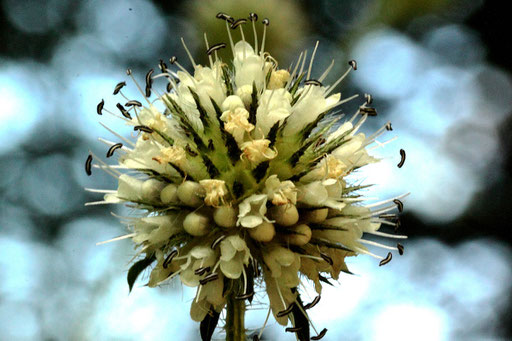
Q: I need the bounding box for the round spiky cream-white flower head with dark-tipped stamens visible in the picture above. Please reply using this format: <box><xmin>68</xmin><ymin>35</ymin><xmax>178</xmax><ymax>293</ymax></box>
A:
<box><xmin>86</xmin><ymin>14</ymin><xmax>403</xmax><ymax>333</ymax></box>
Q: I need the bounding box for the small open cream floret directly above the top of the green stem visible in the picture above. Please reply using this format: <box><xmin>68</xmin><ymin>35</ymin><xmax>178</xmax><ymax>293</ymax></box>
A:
<box><xmin>220</xmin><ymin>235</ymin><xmax>251</xmax><ymax>279</ymax></box>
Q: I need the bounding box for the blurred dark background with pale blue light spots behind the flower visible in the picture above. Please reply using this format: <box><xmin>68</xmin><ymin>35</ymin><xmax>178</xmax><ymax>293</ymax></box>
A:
<box><xmin>0</xmin><ymin>0</ymin><xmax>512</xmax><ymax>341</ymax></box>
